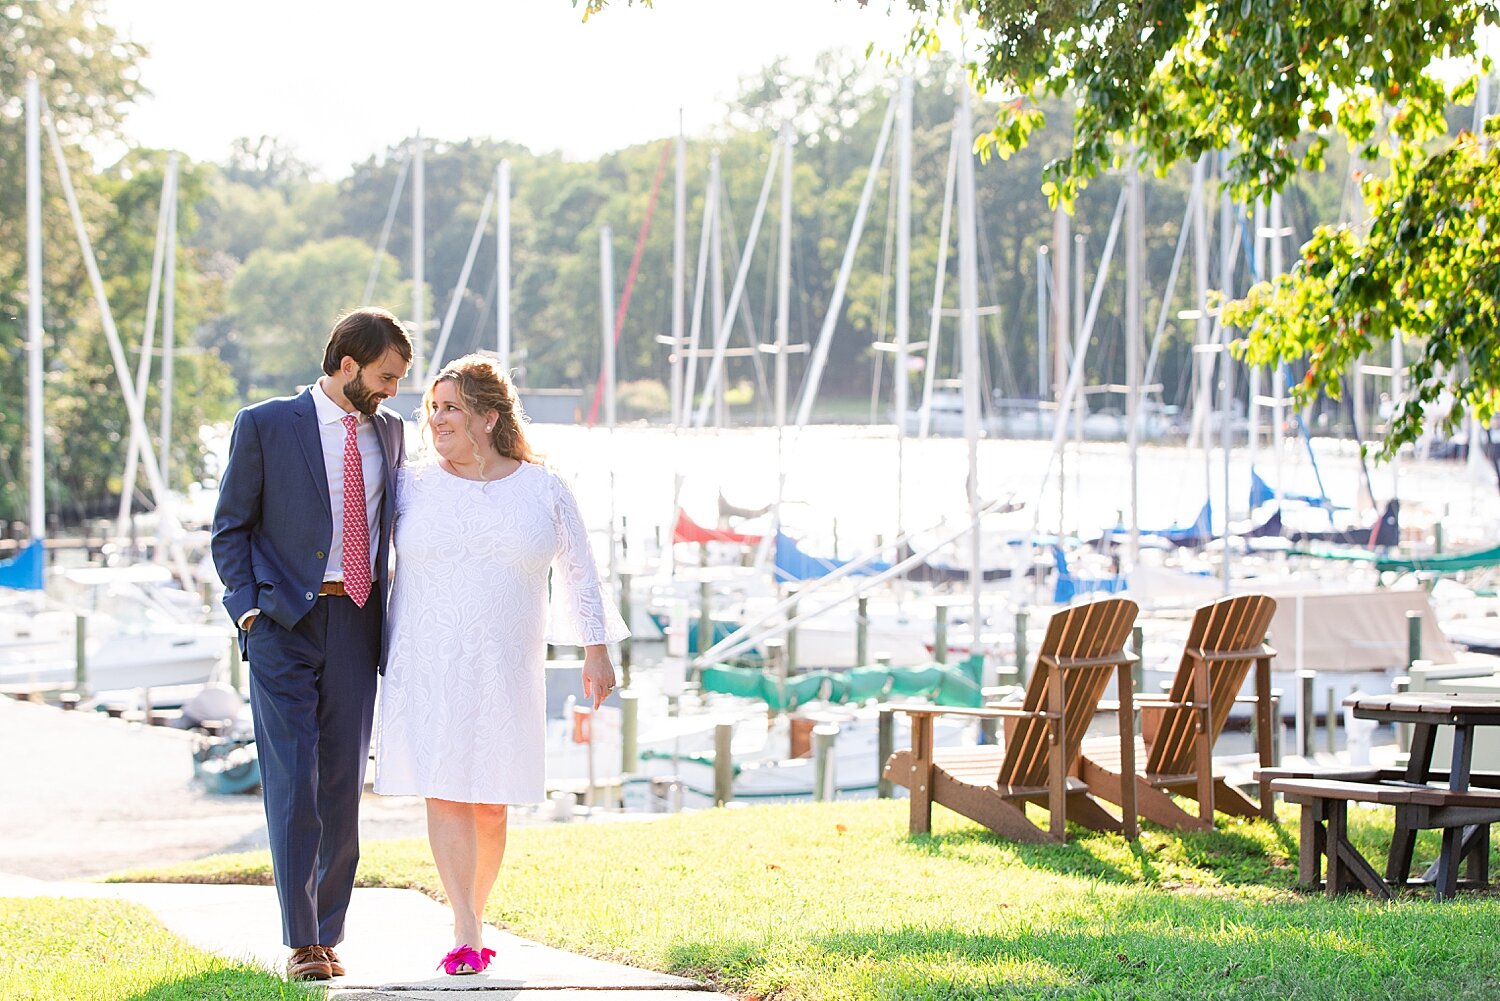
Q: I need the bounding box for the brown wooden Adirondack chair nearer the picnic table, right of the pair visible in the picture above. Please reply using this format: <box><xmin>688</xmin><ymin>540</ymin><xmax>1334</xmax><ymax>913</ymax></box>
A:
<box><xmin>1079</xmin><ymin>594</ymin><xmax>1277</xmax><ymax>830</ymax></box>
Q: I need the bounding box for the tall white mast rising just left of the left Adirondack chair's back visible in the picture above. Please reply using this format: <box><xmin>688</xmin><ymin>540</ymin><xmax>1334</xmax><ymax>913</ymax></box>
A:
<box><xmin>959</xmin><ymin>81</ymin><xmax>996</xmax><ymax>686</ymax></box>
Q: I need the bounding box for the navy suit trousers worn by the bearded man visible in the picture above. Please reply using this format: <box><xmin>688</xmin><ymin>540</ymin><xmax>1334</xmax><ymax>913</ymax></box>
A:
<box><xmin>246</xmin><ymin>585</ymin><xmax>381</xmax><ymax>948</ymax></box>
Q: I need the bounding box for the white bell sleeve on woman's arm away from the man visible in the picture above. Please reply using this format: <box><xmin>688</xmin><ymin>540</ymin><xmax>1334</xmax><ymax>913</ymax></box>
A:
<box><xmin>548</xmin><ymin>474</ymin><xmax>630</xmax><ymax>647</ymax></box>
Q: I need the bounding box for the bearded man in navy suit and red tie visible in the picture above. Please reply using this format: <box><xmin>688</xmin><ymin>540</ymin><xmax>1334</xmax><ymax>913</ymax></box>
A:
<box><xmin>213</xmin><ymin>309</ymin><xmax>411</xmax><ymax>980</ymax></box>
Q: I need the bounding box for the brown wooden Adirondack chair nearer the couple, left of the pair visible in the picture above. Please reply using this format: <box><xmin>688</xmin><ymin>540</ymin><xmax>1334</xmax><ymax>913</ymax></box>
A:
<box><xmin>885</xmin><ymin>597</ymin><xmax>1137</xmax><ymax>842</ymax></box>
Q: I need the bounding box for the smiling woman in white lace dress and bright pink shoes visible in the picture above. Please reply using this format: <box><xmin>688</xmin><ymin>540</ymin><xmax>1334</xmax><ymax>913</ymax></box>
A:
<box><xmin>375</xmin><ymin>354</ymin><xmax>629</xmax><ymax>974</ymax></box>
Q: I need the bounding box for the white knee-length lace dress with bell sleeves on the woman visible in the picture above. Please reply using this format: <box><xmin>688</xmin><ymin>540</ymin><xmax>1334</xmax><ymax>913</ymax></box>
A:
<box><xmin>375</xmin><ymin>462</ymin><xmax>629</xmax><ymax>803</ymax></box>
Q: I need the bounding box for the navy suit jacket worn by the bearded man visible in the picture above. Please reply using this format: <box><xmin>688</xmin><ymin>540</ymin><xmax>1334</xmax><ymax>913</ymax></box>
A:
<box><xmin>212</xmin><ymin>389</ymin><xmax>407</xmax><ymax>668</ymax></box>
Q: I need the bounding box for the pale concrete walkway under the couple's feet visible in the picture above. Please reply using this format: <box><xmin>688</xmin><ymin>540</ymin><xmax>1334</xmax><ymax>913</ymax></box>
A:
<box><xmin>0</xmin><ymin>876</ymin><xmax>726</xmax><ymax>1001</ymax></box>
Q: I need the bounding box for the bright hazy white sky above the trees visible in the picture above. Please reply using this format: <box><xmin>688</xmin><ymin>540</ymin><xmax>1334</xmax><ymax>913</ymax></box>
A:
<box><xmin>107</xmin><ymin>0</ymin><xmax>909</xmax><ymax>177</ymax></box>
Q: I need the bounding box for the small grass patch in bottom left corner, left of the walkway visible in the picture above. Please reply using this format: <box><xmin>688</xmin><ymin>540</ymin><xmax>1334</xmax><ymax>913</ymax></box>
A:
<box><xmin>0</xmin><ymin>897</ymin><xmax>324</xmax><ymax>1001</ymax></box>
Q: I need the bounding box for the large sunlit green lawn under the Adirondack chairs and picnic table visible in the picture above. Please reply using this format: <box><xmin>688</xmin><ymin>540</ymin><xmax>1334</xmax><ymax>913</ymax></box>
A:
<box><xmin>108</xmin><ymin>801</ymin><xmax>1500</xmax><ymax>1001</ymax></box>
